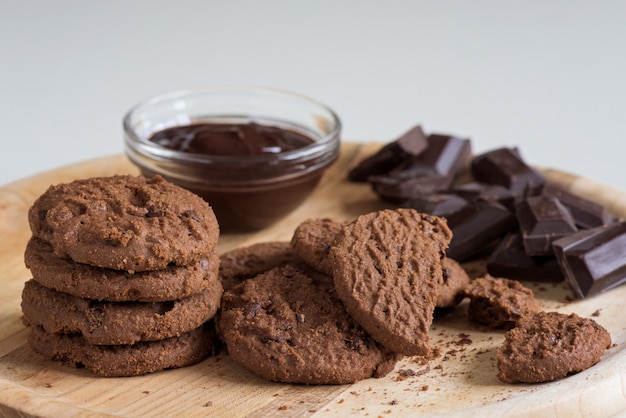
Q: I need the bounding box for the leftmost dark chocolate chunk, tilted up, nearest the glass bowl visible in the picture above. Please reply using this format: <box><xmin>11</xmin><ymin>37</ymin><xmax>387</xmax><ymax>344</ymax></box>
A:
<box><xmin>348</xmin><ymin>125</ymin><xmax>427</xmax><ymax>182</ymax></box>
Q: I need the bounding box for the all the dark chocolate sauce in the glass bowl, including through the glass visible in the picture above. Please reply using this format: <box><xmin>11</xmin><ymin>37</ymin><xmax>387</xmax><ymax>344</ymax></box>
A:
<box><xmin>142</xmin><ymin>122</ymin><xmax>324</xmax><ymax>232</ymax></box>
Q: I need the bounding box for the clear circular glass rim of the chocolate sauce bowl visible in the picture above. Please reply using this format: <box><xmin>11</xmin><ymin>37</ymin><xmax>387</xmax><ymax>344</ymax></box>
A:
<box><xmin>122</xmin><ymin>84</ymin><xmax>342</xmax><ymax>164</ymax></box>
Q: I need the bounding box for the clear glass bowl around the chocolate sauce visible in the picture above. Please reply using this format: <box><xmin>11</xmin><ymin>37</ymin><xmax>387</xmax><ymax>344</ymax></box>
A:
<box><xmin>123</xmin><ymin>86</ymin><xmax>341</xmax><ymax>232</ymax></box>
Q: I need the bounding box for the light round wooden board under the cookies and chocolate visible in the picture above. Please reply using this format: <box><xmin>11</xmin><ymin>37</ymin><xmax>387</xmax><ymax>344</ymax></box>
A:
<box><xmin>0</xmin><ymin>143</ymin><xmax>626</xmax><ymax>417</ymax></box>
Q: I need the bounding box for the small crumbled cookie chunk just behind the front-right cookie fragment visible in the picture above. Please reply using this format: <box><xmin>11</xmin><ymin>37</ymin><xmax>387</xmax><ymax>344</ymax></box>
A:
<box><xmin>463</xmin><ymin>274</ymin><xmax>541</xmax><ymax>329</ymax></box>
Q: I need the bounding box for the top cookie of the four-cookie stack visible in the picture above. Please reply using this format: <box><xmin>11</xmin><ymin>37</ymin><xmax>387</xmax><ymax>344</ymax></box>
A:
<box><xmin>28</xmin><ymin>176</ymin><xmax>219</xmax><ymax>271</ymax></box>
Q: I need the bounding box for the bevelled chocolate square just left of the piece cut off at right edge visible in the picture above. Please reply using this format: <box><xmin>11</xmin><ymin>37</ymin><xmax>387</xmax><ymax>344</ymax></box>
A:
<box><xmin>516</xmin><ymin>195</ymin><xmax>578</xmax><ymax>255</ymax></box>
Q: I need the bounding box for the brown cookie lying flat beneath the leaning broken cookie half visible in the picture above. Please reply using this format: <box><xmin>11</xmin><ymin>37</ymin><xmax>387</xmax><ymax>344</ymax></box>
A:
<box><xmin>218</xmin><ymin>264</ymin><xmax>398</xmax><ymax>384</ymax></box>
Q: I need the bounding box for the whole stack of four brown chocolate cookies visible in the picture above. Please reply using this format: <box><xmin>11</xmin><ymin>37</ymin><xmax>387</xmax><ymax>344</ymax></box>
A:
<box><xmin>22</xmin><ymin>176</ymin><xmax>223</xmax><ymax>376</ymax></box>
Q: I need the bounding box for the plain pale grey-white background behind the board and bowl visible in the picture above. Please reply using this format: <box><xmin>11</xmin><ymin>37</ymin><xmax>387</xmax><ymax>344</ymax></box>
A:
<box><xmin>0</xmin><ymin>0</ymin><xmax>626</xmax><ymax>190</ymax></box>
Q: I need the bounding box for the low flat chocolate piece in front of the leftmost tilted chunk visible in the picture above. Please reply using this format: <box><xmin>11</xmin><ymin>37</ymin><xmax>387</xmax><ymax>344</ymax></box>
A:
<box><xmin>368</xmin><ymin>174</ymin><xmax>453</xmax><ymax>202</ymax></box>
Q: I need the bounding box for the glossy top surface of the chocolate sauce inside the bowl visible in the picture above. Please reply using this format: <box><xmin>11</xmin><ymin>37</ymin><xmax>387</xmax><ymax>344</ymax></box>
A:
<box><xmin>149</xmin><ymin>122</ymin><xmax>314</xmax><ymax>155</ymax></box>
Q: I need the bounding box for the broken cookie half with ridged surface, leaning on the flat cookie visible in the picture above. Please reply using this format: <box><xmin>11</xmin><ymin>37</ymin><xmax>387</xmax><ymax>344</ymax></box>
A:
<box><xmin>330</xmin><ymin>209</ymin><xmax>452</xmax><ymax>355</ymax></box>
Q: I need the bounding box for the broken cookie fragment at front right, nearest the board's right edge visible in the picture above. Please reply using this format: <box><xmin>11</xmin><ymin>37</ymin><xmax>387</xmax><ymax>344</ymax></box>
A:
<box><xmin>498</xmin><ymin>312</ymin><xmax>611</xmax><ymax>383</ymax></box>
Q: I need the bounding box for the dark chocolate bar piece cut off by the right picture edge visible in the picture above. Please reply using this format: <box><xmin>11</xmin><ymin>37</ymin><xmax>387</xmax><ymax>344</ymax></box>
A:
<box><xmin>552</xmin><ymin>221</ymin><xmax>626</xmax><ymax>298</ymax></box>
